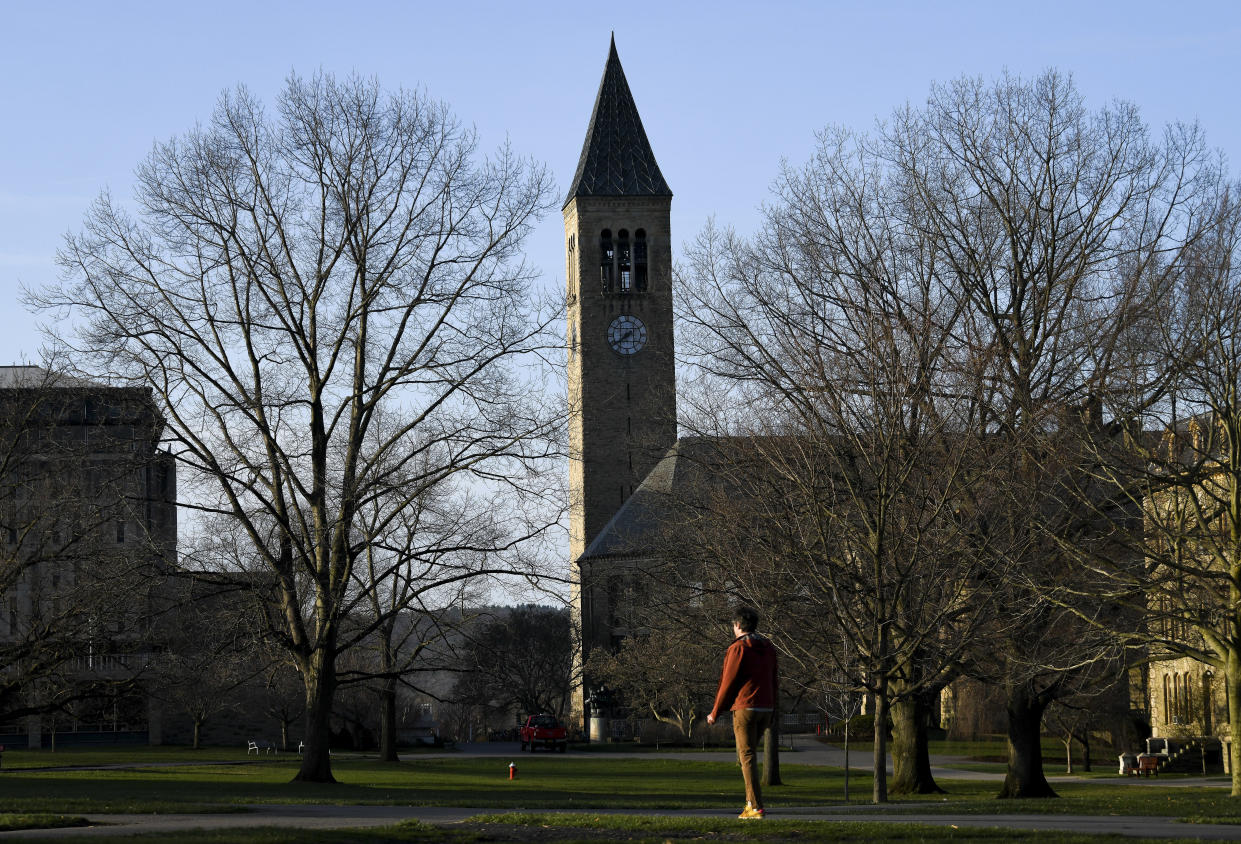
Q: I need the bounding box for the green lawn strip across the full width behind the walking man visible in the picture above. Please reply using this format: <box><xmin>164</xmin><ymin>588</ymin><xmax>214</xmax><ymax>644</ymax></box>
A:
<box><xmin>0</xmin><ymin>755</ymin><xmax>1241</xmax><ymax>819</ymax></box>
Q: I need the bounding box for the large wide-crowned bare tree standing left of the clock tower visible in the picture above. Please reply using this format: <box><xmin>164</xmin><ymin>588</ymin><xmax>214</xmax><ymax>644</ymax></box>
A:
<box><xmin>32</xmin><ymin>74</ymin><xmax>558</xmax><ymax>782</ymax></box>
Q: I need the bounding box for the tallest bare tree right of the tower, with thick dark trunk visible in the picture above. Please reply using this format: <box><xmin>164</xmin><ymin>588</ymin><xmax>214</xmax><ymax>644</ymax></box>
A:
<box><xmin>885</xmin><ymin>71</ymin><xmax>1214</xmax><ymax>797</ymax></box>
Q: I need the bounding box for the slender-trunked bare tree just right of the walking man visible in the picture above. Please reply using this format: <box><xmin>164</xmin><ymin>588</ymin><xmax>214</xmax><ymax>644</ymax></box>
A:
<box><xmin>681</xmin><ymin>199</ymin><xmax>989</xmax><ymax>802</ymax></box>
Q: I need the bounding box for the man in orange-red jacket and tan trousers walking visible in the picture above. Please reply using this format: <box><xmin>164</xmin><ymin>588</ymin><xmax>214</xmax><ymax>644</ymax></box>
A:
<box><xmin>706</xmin><ymin>607</ymin><xmax>777</xmax><ymax>820</ymax></box>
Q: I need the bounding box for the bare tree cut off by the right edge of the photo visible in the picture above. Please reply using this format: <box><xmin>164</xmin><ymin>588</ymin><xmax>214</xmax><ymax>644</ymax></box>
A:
<box><xmin>1056</xmin><ymin>182</ymin><xmax>1241</xmax><ymax>797</ymax></box>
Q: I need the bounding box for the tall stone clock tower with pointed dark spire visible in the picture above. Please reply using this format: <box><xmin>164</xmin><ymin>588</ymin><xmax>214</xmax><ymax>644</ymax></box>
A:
<box><xmin>563</xmin><ymin>38</ymin><xmax>676</xmax><ymax>690</ymax></box>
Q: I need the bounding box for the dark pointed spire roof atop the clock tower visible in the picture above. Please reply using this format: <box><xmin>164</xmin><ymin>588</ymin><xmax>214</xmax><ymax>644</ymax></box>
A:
<box><xmin>565</xmin><ymin>36</ymin><xmax>673</xmax><ymax>205</ymax></box>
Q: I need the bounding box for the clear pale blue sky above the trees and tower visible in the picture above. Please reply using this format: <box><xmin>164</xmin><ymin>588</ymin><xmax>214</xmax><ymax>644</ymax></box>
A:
<box><xmin>0</xmin><ymin>0</ymin><xmax>1241</xmax><ymax>364</ymax></box>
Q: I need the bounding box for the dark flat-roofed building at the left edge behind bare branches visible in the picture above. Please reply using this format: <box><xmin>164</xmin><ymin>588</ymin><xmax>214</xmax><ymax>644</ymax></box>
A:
<box><xmin>0</xmin><ymin>366</ymin><xmax>176</xmax><ymax>747</ymax></box>
